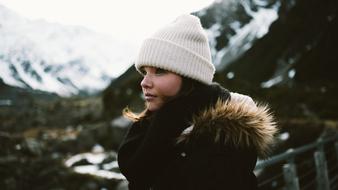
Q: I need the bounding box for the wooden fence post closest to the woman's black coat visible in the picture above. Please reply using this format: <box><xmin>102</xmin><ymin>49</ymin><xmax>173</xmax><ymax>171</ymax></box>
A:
<box><xmin>283</xmin><ymin>163</ymin><xmax>299</xmax><ymax>190</ymax></box>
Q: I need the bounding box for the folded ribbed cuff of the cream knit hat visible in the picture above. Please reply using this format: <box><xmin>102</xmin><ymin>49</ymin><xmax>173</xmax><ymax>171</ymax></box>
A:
<box><xmin>135</xmin><ymin>38</ymin><xmax>215</xmax><ymax>84</ymax></box>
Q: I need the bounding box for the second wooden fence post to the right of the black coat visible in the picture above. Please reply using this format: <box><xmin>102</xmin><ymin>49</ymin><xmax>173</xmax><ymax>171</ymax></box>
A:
<box><xmin>314</xmin><ymin>151</ymin><xmax>330</xmax><ymax>190</ymax></box>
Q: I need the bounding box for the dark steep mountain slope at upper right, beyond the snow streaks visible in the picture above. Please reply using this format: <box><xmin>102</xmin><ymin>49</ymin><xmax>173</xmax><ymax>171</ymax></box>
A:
<box><xmin>222</xmin><ymin>0</ymin><xmax>338</xmax><ymax>88</ymax></box>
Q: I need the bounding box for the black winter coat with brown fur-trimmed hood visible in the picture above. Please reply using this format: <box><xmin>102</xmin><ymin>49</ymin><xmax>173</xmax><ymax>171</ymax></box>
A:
<box><xmin>118</xmin><ymin>84</ymin><xmax>276</xmax><ymax>190</ymax></box>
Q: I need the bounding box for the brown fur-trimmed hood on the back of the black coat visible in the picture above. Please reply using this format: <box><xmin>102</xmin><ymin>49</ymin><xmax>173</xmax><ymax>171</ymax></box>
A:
<box><xmin>177</xmin><ymin>93</ymin><xmax>278</xmax><ymax>158</ymax></box>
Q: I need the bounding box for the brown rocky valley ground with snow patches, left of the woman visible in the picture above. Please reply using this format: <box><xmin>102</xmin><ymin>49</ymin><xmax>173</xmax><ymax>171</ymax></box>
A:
<box><xmin>0</xmin><ymin>81</ymin><xmax>126</xmax><ymax>190</ymax></box>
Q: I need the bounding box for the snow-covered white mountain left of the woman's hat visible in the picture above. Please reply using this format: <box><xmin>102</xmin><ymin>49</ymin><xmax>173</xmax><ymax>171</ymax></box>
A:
<box><xmin>0</xmin><ymin>5</ymin><xmax>134</xmax><ymax>96</ymax></box>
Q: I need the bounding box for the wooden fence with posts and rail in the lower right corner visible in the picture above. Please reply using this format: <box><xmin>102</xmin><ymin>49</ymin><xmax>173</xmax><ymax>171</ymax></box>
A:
<box><xmin>255</xmin><ymin>135</ymin><xmax>338</xmax><ymax>190</ymax></box>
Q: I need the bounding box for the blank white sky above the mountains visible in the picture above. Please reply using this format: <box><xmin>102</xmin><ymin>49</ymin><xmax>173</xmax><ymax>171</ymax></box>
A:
<box><xmin>0</xmin><ymin>0</ymin><xmax>214</xmax><ymax>48</ymax></box>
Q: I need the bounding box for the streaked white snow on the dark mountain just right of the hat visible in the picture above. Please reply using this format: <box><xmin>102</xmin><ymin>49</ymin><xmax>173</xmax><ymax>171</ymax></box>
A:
<box><xmin>202</xmin><ymin>0</ymin><xmax>280</xmax><ymax>70</ymax></box>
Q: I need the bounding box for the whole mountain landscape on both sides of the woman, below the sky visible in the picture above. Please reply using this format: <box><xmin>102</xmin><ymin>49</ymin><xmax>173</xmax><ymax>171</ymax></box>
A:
<box><xmin>0</xmin><ymin>0</ymin><xmax>338</xmax><ymax>189</ymax></box>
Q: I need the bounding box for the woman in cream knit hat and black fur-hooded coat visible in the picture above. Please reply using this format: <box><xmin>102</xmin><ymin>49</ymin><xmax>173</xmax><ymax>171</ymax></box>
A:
<box><xmin>118</xmin><ymin>15</ymin><xmax>276</xmax><ymax>190</ymax></box>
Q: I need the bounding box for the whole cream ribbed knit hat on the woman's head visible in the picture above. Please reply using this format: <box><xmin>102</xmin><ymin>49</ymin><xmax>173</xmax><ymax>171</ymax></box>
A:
<box><xmin>135</xmin><ymin>15</ymin><xmax>215</xmax><ymax>84</ymax></box>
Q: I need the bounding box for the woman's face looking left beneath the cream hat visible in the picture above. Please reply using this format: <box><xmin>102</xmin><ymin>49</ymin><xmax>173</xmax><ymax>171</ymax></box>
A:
<box><xmin>140</xmin><ymin>66</ymin><xmax>182</xmax><ymax>111</ymax></box>
